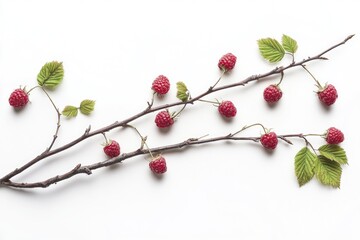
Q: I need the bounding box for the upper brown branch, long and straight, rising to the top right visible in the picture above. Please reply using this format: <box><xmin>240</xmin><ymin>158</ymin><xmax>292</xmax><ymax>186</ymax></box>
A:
<box><xmin>0</xmin><ymin>35</ymin><xmax>354</xmax><ymax>184</ymax></box>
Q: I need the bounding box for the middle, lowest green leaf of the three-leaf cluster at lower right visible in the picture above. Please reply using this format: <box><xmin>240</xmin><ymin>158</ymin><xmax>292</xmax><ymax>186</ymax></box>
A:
<box><xmin>315</xmin><ymin>155</ymin><xmax>342</xmax><ymax>188</ymax></box>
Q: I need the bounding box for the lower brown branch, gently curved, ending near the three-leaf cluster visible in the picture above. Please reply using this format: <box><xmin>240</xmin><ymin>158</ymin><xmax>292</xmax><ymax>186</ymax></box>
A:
<box><xmin>0</xmin><ymin>134</ymin><xmax>310</xmax><ymax>188</ymax></box>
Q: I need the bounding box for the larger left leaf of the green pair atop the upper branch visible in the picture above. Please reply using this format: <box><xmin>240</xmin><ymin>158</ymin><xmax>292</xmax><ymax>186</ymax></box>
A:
<box><xmin>258</xmin><ymin>38</ymin><xmax>285</xmax><ymax>63</ymax></box>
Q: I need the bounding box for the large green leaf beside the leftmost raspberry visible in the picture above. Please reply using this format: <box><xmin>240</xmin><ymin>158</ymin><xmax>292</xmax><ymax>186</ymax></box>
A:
<box><xmin>37</xmin><ymin>61</ymin><xmax>64</xmax><ymax>88</ymax></box>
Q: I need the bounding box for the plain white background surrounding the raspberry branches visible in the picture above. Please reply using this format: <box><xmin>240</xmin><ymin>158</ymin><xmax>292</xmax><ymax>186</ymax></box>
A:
<box><xmin>0</xmin><ymin>0</ymin><xmax>360</xmax><ymax>240</ymax></box>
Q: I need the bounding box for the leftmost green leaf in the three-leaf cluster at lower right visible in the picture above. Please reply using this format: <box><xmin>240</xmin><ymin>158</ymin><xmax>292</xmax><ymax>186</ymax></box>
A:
<box><xmin>295</xmin><ymin>147</ymin><xmax>316</xmax><ymax>187</ymax></box>
